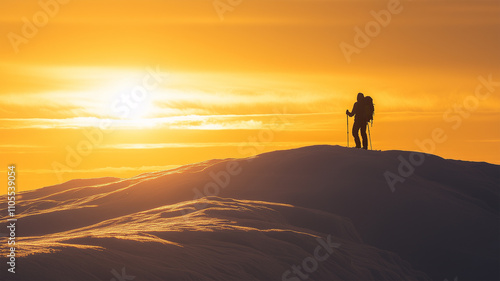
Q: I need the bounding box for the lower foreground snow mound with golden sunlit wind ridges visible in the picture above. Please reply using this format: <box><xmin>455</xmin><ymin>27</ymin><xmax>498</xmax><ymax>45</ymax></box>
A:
<box><xmin>0</xmin><ymin>197</ymin><xmax>429</xmax><ymax>280</ymax></box>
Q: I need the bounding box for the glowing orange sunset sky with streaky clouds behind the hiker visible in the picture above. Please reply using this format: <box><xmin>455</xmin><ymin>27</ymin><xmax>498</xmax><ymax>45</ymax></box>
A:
<box><xmin>0</xmin><ymin>0</ymin><xmax>500</xmax><ymax>193</ymax></box>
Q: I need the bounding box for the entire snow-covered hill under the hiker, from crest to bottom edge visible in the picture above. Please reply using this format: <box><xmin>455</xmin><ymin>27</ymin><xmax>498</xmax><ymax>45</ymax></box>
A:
<box><xmin>0</xmin><ymin>146</ymin><xmax>500</xmax><ymax>281</ymax></box>
